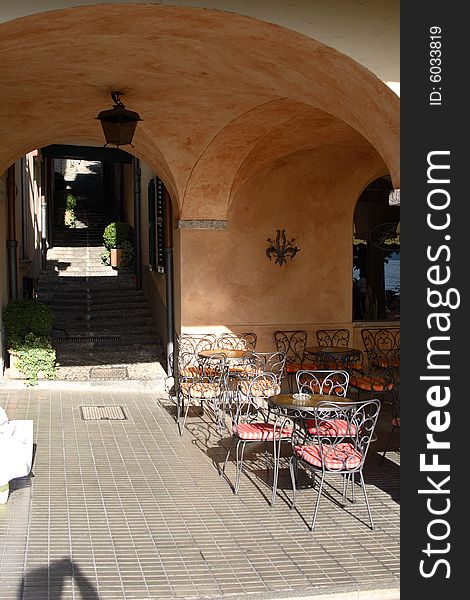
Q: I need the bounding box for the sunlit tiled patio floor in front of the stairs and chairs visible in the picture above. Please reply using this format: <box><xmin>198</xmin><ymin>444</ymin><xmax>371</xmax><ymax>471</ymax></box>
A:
<box><xmin>0</xmin><ymin>388</ymin><xmax>399</xmax><ymax>600</ymax></box>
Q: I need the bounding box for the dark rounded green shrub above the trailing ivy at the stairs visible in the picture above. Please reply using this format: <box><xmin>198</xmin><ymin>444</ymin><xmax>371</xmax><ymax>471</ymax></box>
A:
<box><xmin>2</xmin><ymin>299</ymin><xmax>54</xmax><ymax>342</ymax></box>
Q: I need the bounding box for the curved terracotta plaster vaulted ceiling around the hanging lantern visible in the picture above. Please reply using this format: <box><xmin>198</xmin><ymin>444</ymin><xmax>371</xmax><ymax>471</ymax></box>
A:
<box><xmin>0</xmin><ymin>4</ymin><xmax>399</xmax><ymax>218</ymax></box>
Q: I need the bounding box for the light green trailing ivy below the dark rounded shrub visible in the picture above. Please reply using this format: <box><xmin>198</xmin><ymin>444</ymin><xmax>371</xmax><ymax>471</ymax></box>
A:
<box><xmin>9</xmin><ymin>333</ymin><xmax>56</xmax><ymax>385</ymax></box>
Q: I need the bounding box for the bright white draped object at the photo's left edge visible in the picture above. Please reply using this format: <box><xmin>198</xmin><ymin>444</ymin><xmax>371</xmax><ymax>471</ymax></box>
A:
<box><xmin>0</xmin><ymin>407</ymin><xmax>33</xmax><ymax>487</ymax></box>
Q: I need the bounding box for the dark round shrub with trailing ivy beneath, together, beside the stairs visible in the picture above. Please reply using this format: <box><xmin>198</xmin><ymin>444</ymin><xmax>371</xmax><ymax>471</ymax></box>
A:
<box><xmin>2</xmin><ymin>299</ymin><xmax>56</xmax><ymax>385</ymax></box>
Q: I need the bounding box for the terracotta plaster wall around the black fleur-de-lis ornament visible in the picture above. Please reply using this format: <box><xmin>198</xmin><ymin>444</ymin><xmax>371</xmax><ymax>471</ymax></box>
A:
<box><xmin>181</xmin><ymin>145</ymin><xmax>385</xmax><ymax>349</ymax></box>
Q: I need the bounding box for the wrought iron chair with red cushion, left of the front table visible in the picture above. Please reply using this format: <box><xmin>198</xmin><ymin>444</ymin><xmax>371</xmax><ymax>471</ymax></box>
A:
<box><xmin>220</xmin><ymin>373</ymin><xmax>292</xmax><ymax>494</ymax></box>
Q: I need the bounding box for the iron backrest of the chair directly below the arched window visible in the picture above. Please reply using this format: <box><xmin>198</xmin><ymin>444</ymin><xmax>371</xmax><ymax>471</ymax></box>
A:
<box><xmin>361</xmin><ymin>327</ymin><xmax>400</xmax><ymax>369</ymax></box>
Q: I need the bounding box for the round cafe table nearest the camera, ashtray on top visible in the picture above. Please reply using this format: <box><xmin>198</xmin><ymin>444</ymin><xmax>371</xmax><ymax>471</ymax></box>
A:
<box><xmin>267</xmin><ymin>394</ymin><xmax>355</xmax><ymax>506</ymax></box>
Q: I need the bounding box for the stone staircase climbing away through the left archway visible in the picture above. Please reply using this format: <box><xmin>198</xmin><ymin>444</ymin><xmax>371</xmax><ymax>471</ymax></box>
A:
<box><xmin>36</xmin><ymin>162</ymin><xmax>166</xmax><ymax>389</ymax></box>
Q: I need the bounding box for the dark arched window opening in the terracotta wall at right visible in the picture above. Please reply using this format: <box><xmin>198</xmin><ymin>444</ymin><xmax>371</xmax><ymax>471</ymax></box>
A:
<box><xmin>353</xmin><ymin>177</ymin><xmax>400</xmax><ymax>321</ymax></box>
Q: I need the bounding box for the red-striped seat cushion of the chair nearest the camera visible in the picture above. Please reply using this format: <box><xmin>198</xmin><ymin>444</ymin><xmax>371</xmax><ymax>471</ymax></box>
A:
<box><xmin>294</xmin><ymin>442</ymin><xmax>362</xmax><ymax>471</ymax></box>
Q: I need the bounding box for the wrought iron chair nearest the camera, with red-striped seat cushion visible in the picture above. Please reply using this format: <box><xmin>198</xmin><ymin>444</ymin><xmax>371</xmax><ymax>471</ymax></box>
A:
<box><xmin>290</xmin><ymin>399</ymin><xmax>380</xmax><ymax>531</ymax></box>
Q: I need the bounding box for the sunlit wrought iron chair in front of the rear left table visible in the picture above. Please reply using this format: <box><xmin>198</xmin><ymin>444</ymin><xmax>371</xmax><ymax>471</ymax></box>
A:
<box><xmin>177</xmin><ymin>350</ymin><xmax>227</xmax><ymax>435</ymax></box>
